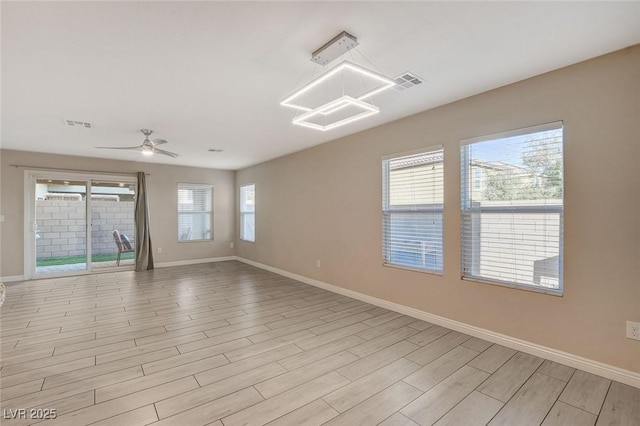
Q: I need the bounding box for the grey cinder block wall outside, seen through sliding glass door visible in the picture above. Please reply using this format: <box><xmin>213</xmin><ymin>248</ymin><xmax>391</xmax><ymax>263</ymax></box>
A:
<box><xmin>36</xmin><ymin>200</ymin><xmax>135</xmax><ymax>259</ymax></box>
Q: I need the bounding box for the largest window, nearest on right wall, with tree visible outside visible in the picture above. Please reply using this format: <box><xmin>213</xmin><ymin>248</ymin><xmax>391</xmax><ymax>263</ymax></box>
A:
<box><xmin>461</xmin><ymin>122</ymin><xmax>564</xmax><ymax>293</ymax></box>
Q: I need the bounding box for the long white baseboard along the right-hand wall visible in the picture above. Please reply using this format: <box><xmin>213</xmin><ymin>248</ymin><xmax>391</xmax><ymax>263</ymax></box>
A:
<box><xmin>236</xmin><ymin>257</ymin><xmax>640</xmax><ymax>388</ymax></box>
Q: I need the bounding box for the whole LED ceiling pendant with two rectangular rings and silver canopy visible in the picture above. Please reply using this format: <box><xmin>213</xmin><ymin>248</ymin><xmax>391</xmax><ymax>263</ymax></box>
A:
<box><xmin>280</xmin><ymin>31</ymin><xmax>396</xmax><ymax>131</ymax></box>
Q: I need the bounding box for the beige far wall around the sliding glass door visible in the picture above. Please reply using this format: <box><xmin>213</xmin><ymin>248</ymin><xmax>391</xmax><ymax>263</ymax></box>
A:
<box><xmin>0</xmin><ymin>150</ymin><xmax>235</xmax><ymax>277</ymax></box>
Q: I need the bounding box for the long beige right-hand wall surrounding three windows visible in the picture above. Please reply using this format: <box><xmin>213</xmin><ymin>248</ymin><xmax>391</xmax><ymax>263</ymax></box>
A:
<box><xmin>236</xmin><ymin>46</ymin><xmax>640</xmax><ymax>372</ymax></box>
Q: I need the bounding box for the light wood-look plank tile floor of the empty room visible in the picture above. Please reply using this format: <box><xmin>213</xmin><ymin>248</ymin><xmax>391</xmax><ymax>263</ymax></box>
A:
<box><xmin>0</xmin><ymin>261</ymin><xmax>640</xmax><ymax>426</ymax></box>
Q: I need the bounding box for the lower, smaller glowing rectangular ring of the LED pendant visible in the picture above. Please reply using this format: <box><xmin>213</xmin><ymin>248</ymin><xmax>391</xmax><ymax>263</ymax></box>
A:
<box><xmin>293</xmin><ymin>96</ymin><xmax>380</xmax><ymax>132</ymax></box>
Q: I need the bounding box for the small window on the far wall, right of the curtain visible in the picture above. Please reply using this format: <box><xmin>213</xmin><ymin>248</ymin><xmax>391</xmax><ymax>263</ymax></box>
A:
<box><xmin>178</xmin><ymin>183</ymin><xmax>213</xmax><ymax>241</ymax></box>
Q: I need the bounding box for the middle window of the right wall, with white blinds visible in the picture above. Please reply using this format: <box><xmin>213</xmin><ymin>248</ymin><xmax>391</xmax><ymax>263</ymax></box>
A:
<box><xmin>382</xmin><ymin>147</ymin><xmax>444</xmax><ymax>273</ymax></box>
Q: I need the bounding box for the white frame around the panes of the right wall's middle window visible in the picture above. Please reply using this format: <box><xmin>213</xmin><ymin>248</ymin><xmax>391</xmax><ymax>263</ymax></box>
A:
<box><xmin>381</xmin><ymin>145</ymin><xmax>445</xmax><ymax>276</ymax></box>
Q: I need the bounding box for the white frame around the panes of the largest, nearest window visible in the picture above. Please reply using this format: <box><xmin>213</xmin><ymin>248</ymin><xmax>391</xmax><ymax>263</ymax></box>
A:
<box><xmin>460</xmin><ymin>121</ymin><xmax>565</xmax><ymax>296</ymax></box>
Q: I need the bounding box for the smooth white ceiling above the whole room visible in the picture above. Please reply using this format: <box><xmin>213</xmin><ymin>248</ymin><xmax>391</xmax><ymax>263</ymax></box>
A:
<box><xmin>1</xmin><ymin>1</ymin><xmax>640</xmax><ymax>169</ymax></box>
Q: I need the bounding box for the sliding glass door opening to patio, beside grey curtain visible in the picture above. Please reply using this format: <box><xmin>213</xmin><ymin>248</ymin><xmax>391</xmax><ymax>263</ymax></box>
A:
<box><xmin>25</xmin><ymin>172</ymin><xmax>136</xmax><ymax>278</ymax></box>
